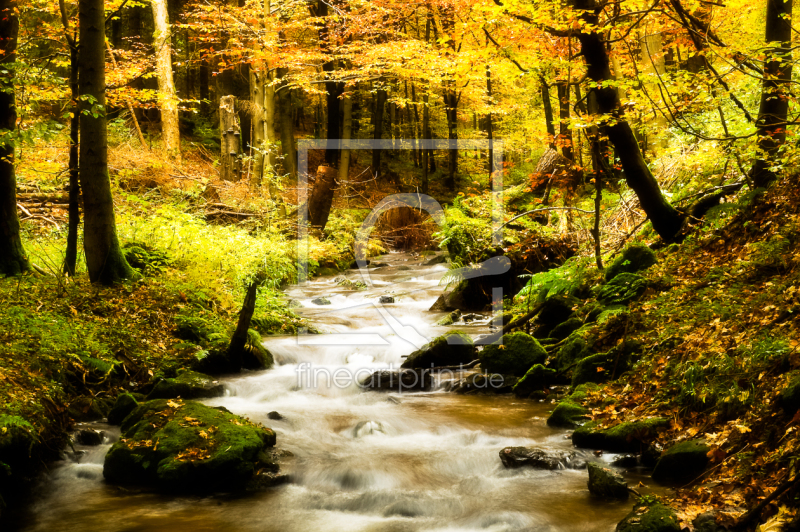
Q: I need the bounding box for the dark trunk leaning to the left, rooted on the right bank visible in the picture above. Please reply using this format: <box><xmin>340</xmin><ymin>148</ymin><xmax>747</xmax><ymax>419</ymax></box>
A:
<box><xmin>574</xmin><ymin>0</ymin><xmax>683</xmax><ymax>240</ymax></box>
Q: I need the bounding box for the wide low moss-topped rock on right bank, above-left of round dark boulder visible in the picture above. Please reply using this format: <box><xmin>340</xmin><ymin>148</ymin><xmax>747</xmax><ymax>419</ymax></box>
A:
<box><xmin>572</xmin><ymin>418</ymin><xmax>669</xmax><ymax>453</ymax></box>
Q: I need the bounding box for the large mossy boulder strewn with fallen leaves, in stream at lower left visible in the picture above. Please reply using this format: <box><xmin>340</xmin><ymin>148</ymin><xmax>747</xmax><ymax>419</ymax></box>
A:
<box><xmin>103</xmin><ymin>399</ymin><xmax>275</xmax><ymax>493</ymax></box>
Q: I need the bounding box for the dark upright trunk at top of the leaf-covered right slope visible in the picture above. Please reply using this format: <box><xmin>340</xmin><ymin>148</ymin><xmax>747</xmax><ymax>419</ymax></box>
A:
<box><xmin>750</xmin><ymin>0</ymin><xmax>792</xmax><ymax>187</ymax></box>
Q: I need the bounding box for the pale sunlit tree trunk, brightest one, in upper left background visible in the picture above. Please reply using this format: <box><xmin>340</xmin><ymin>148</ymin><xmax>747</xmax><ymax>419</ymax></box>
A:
<box><xmin>151</xmin><ymin>0</ymin><xmax>181</xmax><ymax>161</ymax></box>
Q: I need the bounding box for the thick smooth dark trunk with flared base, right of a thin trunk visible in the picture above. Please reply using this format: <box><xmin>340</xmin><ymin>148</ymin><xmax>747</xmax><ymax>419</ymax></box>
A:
<box><xmin>78</xmin><ymin>0</ymin><xmax>135</xmax><ymax>285</ymax></box>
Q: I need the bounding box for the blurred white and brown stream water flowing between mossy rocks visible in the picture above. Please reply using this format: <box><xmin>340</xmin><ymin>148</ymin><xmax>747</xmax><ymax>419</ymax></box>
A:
<box><xmin>15</xmin><ymin>253</ymin><xmax>660</xmax><ymax>532</ymax></box>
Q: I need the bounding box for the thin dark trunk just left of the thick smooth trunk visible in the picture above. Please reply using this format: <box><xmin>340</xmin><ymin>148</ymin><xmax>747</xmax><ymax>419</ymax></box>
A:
<box><xmin>64</xmin><ymin>43</ymin><xmax>80</xmax><ymax>277</ymax></box>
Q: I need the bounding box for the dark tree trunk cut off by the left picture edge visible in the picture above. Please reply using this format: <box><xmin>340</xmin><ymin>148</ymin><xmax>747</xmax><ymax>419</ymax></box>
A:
<box><xmin>0</xmin><ymin>0</ymin><xmax>31</xmax><ymax>275</ymax></box>
